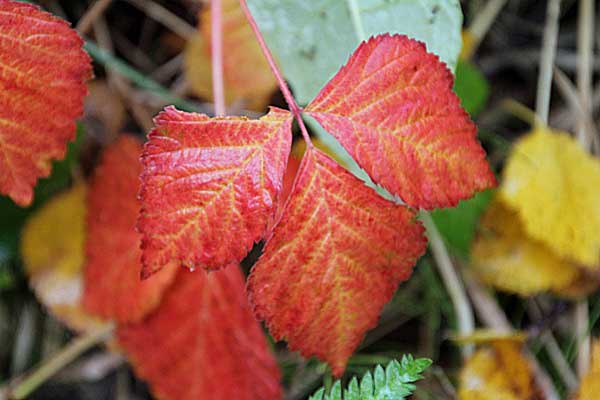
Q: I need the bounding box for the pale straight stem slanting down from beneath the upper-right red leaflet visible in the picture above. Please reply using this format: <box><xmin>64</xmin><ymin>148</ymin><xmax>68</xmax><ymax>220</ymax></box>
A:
<box><xmin>421</xmin><ymin>212</ymin><xmax>475</xmax><ymax>357</ymax></box>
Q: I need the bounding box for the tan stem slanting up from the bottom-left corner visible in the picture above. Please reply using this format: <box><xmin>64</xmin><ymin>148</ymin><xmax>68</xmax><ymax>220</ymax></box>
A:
<box><xmin>7</xmin><ymin>324</ymin><xmax>114</xmax><ymax>400</ymax></box>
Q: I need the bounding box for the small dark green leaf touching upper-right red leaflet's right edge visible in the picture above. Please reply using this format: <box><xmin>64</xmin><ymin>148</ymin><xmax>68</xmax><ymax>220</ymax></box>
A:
<box><xmin>454</xmin><ymin>60</ymin><xmax>490</xmax><ymax>117</ymax></box>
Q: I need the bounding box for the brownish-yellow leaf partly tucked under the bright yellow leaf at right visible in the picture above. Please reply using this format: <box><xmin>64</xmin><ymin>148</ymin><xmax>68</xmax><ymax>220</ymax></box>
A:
<box><xmin>471</xmin><ymin>196</ymin><xmax>580</xmax><ymax>296</ymax></box>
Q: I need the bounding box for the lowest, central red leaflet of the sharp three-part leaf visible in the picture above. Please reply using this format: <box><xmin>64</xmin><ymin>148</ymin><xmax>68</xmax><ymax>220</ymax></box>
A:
<box><xmin>248</xmin><ymin>148</ymin><xmax>426</xmax><ymax>375</ymax></box>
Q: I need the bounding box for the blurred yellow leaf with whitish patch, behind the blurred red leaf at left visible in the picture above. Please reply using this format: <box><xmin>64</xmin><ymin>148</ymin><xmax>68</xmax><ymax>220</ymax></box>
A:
<box><xmin>21</xmin><ymin>185</ymin><xmax>102</xmax><ymax>332</ymax></box>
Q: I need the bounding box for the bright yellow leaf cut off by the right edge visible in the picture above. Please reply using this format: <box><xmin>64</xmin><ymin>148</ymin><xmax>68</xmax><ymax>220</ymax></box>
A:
<box><xmin>500</xmin><ymin>127</ymin><xmax>600</xmax><ymax>269</ymax></box>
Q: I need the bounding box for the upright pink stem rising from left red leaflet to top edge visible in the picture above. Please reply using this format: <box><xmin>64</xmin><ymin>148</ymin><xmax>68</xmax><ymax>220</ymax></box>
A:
<box><xmin>210</xmin><ymin>0</ymin><xmax>225</xmax><ymax>116</ymax></box>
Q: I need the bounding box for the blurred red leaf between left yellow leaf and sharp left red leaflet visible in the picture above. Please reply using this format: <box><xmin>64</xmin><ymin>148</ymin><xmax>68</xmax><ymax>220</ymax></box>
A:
<box><xmin>83</xmin><ymin>135</ymin><xmax>177</xmax><ymax>323</ymax></box>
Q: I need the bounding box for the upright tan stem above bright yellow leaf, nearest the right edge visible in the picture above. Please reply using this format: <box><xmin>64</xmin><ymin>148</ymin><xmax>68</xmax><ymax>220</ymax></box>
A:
<box><xmin>577</xmin><ymin>0</ymin><xmax>595</xmax><ymax>149</ymax></box>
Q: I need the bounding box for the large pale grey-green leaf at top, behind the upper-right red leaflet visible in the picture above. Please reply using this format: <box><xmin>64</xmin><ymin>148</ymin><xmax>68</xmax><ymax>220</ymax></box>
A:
<box><xmin>248</xmin><ymin>0</ymin><xmax>462</xmax><ymax>104</ymax></box>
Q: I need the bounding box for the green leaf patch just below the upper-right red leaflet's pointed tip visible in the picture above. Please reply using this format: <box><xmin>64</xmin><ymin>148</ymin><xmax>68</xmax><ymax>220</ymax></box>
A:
<box><xmin>430</xmin><ymin>190</ymin><xmax>493</xmax><ymax>259</ymax></box>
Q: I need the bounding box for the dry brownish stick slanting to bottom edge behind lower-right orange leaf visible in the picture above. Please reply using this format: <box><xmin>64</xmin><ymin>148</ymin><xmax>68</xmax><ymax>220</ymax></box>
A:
<box><xmin>465</xmin><ymin>276</ymin><xmax>560</xmax><ymax>400</ymax></box>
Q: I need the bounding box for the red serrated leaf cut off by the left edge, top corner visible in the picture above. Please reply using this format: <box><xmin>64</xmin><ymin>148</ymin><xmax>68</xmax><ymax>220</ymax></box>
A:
<box><xmin>0</xmin><ymin>0</ymin><xmax>92</xmax><ymax>206</ymax></box>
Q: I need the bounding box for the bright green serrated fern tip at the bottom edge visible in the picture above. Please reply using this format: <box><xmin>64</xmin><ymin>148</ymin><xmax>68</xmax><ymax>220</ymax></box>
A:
<box><xmin>309</xmin><ymin>355</ymin><xmax>431</xmax><ymax>400</ymax></box>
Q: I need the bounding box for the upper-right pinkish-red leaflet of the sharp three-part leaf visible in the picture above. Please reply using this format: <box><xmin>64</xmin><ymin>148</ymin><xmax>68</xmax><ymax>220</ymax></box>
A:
<box><xmin>306</xmin><ymin>35</ymin><xmax>496</xmax><ymax>209</ymax></box>
